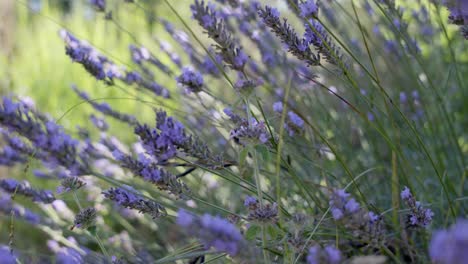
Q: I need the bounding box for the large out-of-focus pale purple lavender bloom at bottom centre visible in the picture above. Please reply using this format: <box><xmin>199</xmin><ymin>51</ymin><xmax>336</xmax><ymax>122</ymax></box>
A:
<box><xmin>177</xmin><ymin>209</ymin><xmax>248</xmax><ymax>256</ymax></box>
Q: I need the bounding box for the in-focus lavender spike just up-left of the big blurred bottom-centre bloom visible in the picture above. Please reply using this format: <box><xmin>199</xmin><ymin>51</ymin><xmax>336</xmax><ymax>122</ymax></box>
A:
<box><xmin>103</xmin><ymin>186</ymin><xmax>167</xmax><ymax>219</ymax></box>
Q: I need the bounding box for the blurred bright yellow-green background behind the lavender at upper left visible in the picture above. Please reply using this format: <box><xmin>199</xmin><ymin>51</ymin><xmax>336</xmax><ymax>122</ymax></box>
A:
<box><xmin>0</xmin><ymin>0</ymin><xmax>189</xmax><ymax>138</ymax></box>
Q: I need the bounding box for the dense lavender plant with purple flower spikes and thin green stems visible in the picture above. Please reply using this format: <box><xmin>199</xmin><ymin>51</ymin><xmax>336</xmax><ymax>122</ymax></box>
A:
<box><xmin>0</xmin><ymin>0</ymin><xmax>468</xmax><ymax>264</ymax></box>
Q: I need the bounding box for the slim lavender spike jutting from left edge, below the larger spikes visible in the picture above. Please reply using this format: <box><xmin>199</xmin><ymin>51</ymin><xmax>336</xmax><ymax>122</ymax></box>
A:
<box><xmin>0</xmin><ymin>179</ymin><xmax>55</xmax><ymax>204</ymax></box>
